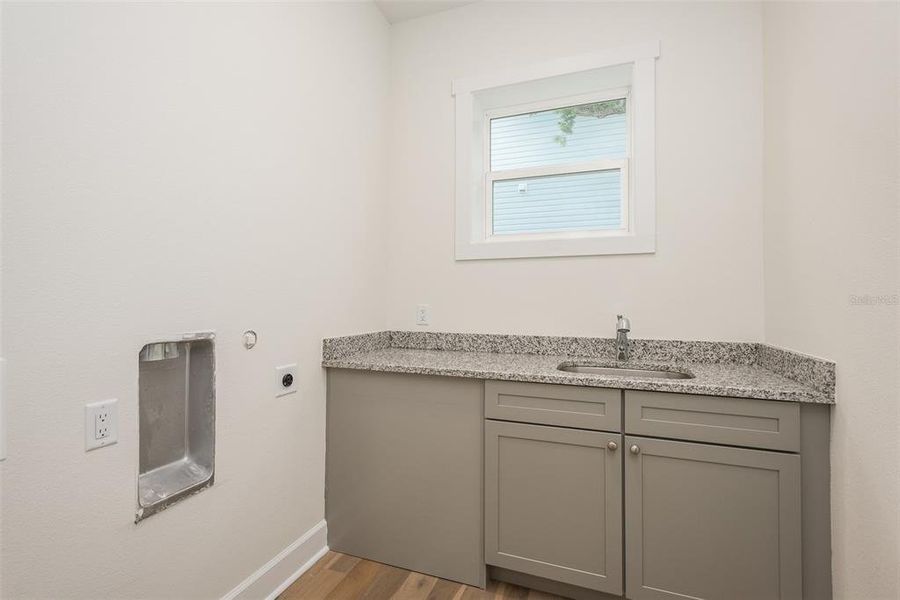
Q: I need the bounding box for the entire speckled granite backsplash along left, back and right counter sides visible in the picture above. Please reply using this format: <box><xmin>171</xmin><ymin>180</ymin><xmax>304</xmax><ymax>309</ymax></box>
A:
<box><xmin>322</xmin><ymin>331</ymin><xmax>835</xmax><ymax>401</ymax></box>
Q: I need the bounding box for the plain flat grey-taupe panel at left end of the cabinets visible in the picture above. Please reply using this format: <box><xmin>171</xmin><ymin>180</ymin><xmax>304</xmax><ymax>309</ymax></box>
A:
<box><xmin>325</xmin><ymin>369</ymin><xmax>485</xmax><ymax>584</ymax></box>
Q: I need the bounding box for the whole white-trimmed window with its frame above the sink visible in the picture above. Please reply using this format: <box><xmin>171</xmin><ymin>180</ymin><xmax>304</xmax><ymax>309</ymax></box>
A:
<box><xmin>454</xmin><ymin>44</ymin><xmax>659</xmax><ymax>260</ymax></box>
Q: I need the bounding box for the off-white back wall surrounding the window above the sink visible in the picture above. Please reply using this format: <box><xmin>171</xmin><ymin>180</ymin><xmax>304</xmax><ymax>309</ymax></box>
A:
<box><xmin>387</xmin><ymin>2</ymin><xmax>763</xmax><ymax>341</ymax></box>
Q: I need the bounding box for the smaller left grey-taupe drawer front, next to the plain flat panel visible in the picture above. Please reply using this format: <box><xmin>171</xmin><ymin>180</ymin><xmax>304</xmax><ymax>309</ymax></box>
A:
<box><xmin>484</xmin><ymin>381</ymin><xmax>622</xmax><ymax>431</ymax></box>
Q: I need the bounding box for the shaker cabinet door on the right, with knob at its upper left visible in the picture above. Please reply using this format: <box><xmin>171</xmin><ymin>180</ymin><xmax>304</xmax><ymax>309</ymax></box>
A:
<box><xmin>623</xmin><ymin>436</ymin><xmax>802</xmax><ymax>600</ymax></box>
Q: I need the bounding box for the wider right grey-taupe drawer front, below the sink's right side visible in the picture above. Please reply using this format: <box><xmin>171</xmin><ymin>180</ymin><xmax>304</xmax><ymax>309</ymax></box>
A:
<box><xmin>625</xmin><ymin>391</ymin><xmax>800</xmax><ymax>452</ymax></box>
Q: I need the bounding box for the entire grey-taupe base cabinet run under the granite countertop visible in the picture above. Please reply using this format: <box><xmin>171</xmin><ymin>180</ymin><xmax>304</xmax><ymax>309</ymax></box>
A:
<box><xmin>325</xmin><ymin>369</ymin><xmax>832</xmax><ymax>600</ymax></box>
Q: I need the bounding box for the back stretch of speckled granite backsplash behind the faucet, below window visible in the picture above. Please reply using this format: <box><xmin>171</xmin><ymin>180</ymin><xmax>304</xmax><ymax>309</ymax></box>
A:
<box><xmin>390</xmin><ymin>331</ymin><xmax>756</xmax><ymax>365</ymax></box>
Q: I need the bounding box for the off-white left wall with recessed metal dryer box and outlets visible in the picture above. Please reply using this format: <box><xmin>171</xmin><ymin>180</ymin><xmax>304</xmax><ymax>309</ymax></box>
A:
<box><xmin>0</xmin><ymin>3</ymin><xmax>389</xmax><ymax>599</ymax></box>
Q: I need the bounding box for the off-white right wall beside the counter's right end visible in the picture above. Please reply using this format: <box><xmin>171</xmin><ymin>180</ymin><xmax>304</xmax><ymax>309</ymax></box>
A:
<box><xmin>764</xmin><ymin>3</ymin><xmax>900</xmax><ymax>600</ymax></box>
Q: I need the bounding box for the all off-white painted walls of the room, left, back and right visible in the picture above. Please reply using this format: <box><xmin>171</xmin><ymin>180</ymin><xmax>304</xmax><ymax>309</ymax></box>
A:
<box><xmin>0</xmin><ymin>3</ymin><xmax>900</xmax><ymax>600</ymax></box>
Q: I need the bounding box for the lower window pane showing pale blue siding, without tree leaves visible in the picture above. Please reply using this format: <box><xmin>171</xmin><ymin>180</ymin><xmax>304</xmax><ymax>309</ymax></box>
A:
<box><xmin>493</xmin><ymin>169</ymin><xmax>622</xmax><ymax>234</ymax></box>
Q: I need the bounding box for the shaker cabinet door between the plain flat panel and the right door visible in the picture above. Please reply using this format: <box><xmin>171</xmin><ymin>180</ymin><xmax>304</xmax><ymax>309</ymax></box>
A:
<box><xmin>485</xmin><ymin>421</ymin><xmax>622</xmax><ymax>594</ymax></box>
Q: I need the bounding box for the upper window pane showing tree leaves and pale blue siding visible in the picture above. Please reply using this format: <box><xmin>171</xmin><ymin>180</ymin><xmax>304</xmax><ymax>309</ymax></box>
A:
<box><xmin>491</xmin><ymin>98</ymin><xmax>626</xmax><ymax>171</ymax></box>
